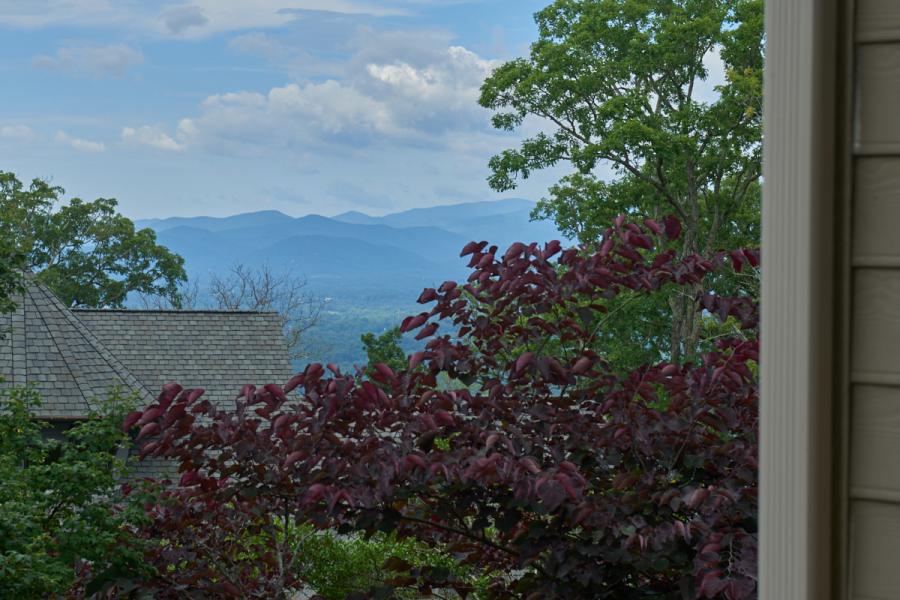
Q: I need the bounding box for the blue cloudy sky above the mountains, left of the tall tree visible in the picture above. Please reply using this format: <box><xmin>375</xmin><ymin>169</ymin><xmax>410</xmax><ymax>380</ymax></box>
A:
<box><xmin>0</xmin><ymin>0</ymin><xmax>576</xmax><ymax>218</ymax></box>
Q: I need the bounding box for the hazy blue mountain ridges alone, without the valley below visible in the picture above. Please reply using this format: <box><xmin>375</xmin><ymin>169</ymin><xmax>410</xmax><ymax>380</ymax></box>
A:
<box><xmin>135</xmin><ymin>198</ymin><xmax>561</xmax><ymax>288</ymax></box>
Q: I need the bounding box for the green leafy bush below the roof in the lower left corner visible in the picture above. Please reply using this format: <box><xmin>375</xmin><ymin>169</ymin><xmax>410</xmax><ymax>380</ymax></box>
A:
<box><xmin>0</xmin><ymin>388</ymin><xmax>148</xmax><ymax>598</ymax></box>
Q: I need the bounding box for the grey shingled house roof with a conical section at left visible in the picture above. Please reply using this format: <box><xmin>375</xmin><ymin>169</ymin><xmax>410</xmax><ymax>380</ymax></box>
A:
<box><xmin>0</xmin><ymin>279</ymin><xmax>291</xmax><ymax>419</ymax></box>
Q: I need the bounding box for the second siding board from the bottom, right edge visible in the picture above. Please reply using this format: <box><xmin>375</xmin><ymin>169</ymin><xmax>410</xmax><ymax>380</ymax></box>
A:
<box><xmin>850</xmin><ymin>385</ymin><xmax>900</xmax><ymax>499</ymax></box>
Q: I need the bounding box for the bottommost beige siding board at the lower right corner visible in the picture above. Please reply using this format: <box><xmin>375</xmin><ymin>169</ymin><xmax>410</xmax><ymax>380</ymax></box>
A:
<box><xmin>850</xmin><ymin>501</ymin><xmax>900</xmax><ymax>600</ymax></box>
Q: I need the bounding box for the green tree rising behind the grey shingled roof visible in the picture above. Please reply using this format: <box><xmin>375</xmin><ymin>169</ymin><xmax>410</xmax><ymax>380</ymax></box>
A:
<box><xmin>0</xmin><ymin>171</ymin><xmax>187</xmax><ymax>307</ymax></box>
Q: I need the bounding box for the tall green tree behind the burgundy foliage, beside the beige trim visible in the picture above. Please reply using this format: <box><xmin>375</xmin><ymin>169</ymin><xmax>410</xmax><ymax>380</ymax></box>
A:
<box><xmin>480</xmin><ymin>0</ymin><xmax>763</xmax><ymax>361</ymax></box>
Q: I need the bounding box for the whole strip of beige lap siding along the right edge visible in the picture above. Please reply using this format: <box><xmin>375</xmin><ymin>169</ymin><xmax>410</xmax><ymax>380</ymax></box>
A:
<box><xmin>848</xmin><ymin>0</ymin><xmax>900</xmax><ymax>600</ymax></box>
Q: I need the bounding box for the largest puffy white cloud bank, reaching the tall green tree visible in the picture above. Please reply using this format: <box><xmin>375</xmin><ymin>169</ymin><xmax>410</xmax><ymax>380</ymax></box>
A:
<box><xmin>128</xmin><ymin>46</ymin><xmax>496</xmax><ymax>155</ymax></box>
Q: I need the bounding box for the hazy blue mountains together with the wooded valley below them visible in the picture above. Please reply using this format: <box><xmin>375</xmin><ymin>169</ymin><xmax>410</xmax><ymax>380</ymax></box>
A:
<box><xmin>135</xmin><ymin>198</ymin><xmax>563</xmax><ymax>365</ymax></box>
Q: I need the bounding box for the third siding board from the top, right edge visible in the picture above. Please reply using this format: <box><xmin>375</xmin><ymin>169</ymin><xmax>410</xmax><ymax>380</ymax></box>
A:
<box><xmin>853</xmin><ymin>159</ymin><xmax>900</xmax><ymax>266</ymax></box>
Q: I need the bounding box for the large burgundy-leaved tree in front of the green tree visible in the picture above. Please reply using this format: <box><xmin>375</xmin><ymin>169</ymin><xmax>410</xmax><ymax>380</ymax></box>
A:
<box><xmin>129</xmin><ymin>218</ymin><xmax>758</xmax><ymax>599</ymax></box>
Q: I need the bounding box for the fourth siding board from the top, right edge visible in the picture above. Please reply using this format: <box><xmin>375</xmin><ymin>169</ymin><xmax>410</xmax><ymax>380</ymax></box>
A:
<box><xmin>851</xmin><ymin>269</ymin><xmax>900</xmax><ymax>384</ymax></box>
